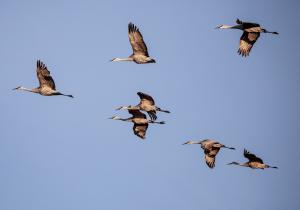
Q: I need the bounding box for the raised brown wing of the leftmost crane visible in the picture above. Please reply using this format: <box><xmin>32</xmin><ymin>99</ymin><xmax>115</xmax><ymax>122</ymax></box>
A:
<box><xmin>36</xmin><ymin>60</ymin><xmax>55</xmax><ymax>90</ymax></box>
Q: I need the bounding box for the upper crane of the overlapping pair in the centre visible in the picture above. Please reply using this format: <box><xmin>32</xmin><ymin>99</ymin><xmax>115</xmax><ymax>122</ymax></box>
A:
<box><xmin>116</xmin><ymin>92</ymin><xmax>170</xmax><ymax>120</ymax></box>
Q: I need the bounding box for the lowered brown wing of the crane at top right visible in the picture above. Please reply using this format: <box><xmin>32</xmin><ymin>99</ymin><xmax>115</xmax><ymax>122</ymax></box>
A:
<box><xmin>238</xmin><ymin>31</ymin><xmax>260</xmax><ymax>57</ymax></box>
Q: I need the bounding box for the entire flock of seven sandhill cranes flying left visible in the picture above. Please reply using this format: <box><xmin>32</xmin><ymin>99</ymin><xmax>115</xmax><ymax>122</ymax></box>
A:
<box><xmin>13</xmin><ymin>19</ymin><xmax>278</xmax><ymax>169</ymax></box>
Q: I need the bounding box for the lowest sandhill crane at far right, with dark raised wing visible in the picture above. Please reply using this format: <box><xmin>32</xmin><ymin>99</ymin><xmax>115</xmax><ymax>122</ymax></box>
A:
<box><xmin>228</xmin><ymin>149</ymin><xmax>278</xmax><ymax>169</ymax></box>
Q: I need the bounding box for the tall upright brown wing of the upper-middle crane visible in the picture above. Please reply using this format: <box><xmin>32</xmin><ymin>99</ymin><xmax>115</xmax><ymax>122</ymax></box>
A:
<box><xmin>128</xmin><ymin>23</ymin><xmax>149</xmax><ymax>57</ymax></box>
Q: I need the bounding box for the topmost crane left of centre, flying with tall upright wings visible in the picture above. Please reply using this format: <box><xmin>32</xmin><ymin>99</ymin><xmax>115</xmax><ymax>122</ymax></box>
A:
<box><xmin>111</xmin><ymin>23</ymin><xmax>155</xmax><ymax>64</ymax></box>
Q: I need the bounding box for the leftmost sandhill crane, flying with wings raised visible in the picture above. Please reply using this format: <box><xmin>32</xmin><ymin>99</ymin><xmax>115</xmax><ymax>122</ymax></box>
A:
<box><xmin>13</xmin><ymin>60</ymin><xmax>73</xmax><ymax>98</ymax></box>
